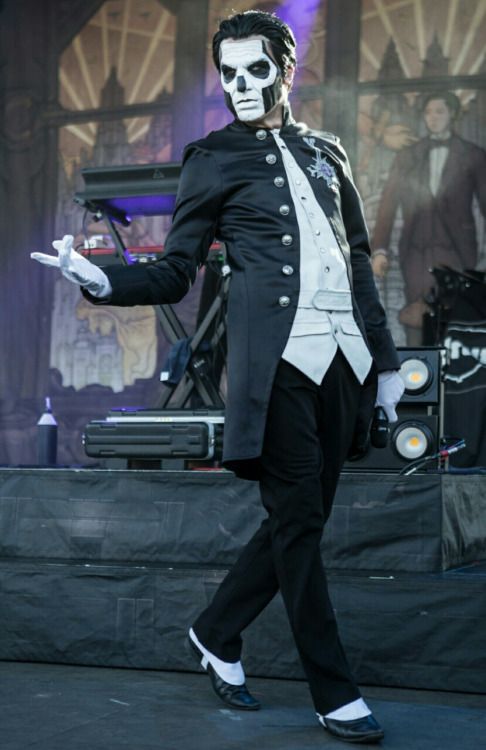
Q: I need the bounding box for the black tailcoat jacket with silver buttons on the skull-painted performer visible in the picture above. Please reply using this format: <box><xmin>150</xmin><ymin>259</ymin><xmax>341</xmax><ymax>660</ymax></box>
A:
<box><xmin>85</xmin><ymin>120</ymin><xmax>400</xmax><ymax>479</ymax></box>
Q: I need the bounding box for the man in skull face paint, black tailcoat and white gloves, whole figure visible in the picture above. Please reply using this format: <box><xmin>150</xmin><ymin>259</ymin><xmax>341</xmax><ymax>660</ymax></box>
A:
<box><xmin>34</xmin><ymin>11</ymin><xmax>403</xmax><ymax>742</ymax></box>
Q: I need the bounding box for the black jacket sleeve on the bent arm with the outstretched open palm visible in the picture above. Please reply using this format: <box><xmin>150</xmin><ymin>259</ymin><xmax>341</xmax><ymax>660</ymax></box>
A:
<box><xmin>83</xmin><ymin>144</ymin><xmax>223</xmax><ymax>307</ymax></box>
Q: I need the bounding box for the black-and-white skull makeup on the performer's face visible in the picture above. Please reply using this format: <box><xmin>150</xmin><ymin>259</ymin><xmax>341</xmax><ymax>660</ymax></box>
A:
<box><xmin>220</xmin><ymin>39</ymin><xmax>282</xmax><ymax>122</ymax></box>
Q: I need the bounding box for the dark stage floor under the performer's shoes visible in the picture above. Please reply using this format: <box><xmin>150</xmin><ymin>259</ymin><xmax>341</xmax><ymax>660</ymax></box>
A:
<box><xmin>0</xmin><ymin>662</ymin><xmax>486</xmax><ymax>750</ymax></box>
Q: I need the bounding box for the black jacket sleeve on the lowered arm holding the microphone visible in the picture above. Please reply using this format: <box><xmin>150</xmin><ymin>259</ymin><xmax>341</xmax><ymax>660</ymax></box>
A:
<box><xmin>340</xmin><ymin>143</ymin><xmax>400</xmax><ymax>372</ymax></box>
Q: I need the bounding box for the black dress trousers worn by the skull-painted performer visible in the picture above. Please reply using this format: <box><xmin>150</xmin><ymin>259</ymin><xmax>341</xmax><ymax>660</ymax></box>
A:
<box><xmin>193</xmin><ymin>351</ymin><xmax>361</xmax><ymax>714</ymax></box>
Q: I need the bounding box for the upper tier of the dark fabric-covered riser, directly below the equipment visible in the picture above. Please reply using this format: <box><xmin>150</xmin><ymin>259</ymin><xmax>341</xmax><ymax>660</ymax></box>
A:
<box><xmin>0</xmin><ymin>469</ymin><xmax>486</xmax><ymax>572</ymax></box>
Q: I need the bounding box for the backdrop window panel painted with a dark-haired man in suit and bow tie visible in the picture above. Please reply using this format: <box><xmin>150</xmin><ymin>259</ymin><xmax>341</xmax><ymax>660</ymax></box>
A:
<box><xmin>357</xmin><ymin>2</ymin><xmax>486</xmax><ymax>346</ymax></box>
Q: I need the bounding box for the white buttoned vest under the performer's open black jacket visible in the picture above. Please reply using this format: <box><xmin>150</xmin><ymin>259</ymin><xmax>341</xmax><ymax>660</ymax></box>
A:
<box><xmin>272</xmin><ymin>130</ymin><xmax>372</xmax><ymax>385</ymax></box>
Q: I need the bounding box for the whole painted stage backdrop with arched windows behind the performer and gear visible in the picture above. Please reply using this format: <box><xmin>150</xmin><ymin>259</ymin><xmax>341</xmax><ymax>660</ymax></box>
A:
<box><xmin>0</xmin><ymin>0</ymin><xmax>486</xmax><ymax>464</ymax></box>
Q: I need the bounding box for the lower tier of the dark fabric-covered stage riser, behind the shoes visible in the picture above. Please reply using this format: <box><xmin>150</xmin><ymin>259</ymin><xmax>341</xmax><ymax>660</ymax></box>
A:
<box><xmin>0</xmin><ymin>561</ymin><xmax>486</xmax><ymax>693</ymax></box>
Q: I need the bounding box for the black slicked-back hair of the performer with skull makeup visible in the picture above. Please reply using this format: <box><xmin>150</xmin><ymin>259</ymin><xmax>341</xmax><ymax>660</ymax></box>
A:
<box><xmin>213</xmin><ymin>10</ymin><xmax>297</xmax><ymax>75</ymax></box>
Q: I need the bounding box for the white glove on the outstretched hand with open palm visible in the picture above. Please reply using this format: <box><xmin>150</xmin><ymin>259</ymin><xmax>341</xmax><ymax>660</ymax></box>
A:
<box><xmin>30</xmin><ymin>234</ymin><xmax>112</xmax><ymax>297</ymax></box>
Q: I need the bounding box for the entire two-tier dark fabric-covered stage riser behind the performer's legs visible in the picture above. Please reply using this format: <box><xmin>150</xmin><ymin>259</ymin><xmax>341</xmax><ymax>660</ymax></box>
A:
<box><xmin>0</xmin><ymin>469</ymin><xmax>486</xmax><ymax>693</ymax></box>
